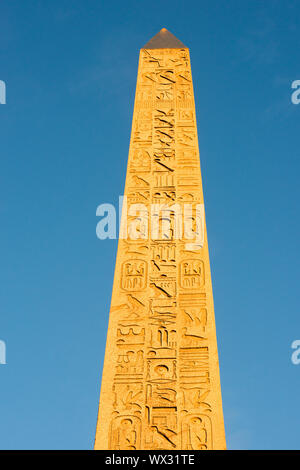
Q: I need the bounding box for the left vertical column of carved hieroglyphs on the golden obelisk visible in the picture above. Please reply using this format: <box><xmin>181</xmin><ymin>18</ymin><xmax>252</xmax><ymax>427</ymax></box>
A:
<box><xmin>95</xmin><ymin>49</ymin><xmax>153</xmax><ymax>450</ymax></box>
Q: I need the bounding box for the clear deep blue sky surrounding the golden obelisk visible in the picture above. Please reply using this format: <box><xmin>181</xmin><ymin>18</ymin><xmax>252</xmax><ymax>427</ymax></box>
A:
<box><xmin>0</xmin><ymin>0</ymin><xmax>300</xmax><ymax>449</ymax></box>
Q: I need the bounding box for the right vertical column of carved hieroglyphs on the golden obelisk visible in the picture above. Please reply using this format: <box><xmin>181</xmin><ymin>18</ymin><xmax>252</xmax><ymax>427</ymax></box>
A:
<box><xmin>175</xmin><ymin>50</ymin><xmax>225</xmax><ymax>450</ymax></box>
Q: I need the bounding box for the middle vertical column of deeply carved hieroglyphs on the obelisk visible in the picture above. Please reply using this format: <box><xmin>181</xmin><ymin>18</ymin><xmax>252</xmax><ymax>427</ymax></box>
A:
<box><xmin>142</xmin><ymin>49</ymin><xmax>178</xmax><ymax>449</ymax></box>
